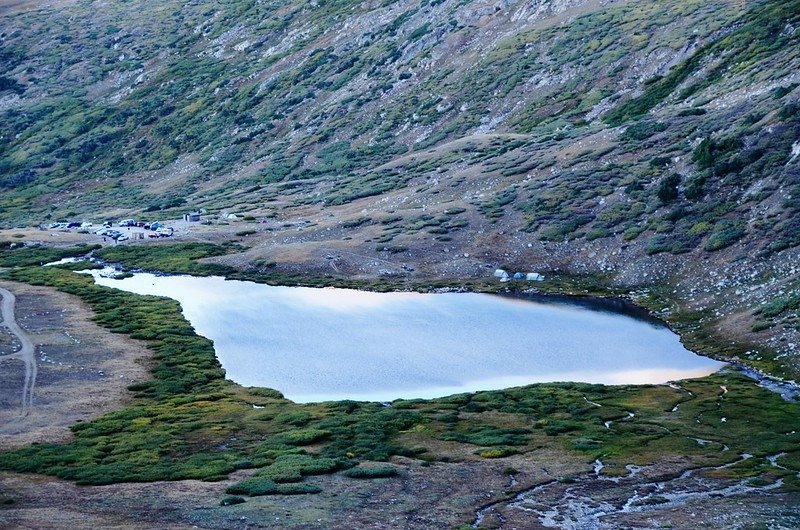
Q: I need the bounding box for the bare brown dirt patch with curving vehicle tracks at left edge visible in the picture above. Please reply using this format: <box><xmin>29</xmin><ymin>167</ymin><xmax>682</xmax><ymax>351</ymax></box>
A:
<box><xmin>0</xmin><ymin>281</ymin><xmax>150</xmax><ymax>450</ymax></box>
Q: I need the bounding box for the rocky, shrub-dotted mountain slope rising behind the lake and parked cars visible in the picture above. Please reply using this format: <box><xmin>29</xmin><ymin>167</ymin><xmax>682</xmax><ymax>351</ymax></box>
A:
<box><xmin>0</xmin><ymin>0</ymin><xmax>800</xmax><ymax>373</ymax></box>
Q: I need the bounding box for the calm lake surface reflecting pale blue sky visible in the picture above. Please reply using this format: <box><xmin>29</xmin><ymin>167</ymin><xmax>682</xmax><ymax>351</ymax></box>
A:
<box><xmin>86</xmin><ymin>271</ymin><xmax>724</xmax><ymax>402</ymax></box>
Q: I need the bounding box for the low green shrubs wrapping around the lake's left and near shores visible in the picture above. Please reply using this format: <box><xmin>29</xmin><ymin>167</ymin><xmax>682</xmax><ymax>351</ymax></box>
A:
<box><xmin>0</xmin><ymin>245</ymin><xmax>800</xmax><ymax>504</ymax></box>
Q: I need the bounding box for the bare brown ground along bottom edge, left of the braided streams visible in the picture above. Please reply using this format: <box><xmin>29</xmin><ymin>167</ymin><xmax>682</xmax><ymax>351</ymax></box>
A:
<box><xmin>0</xmin><ymin>454</ymin><xmax>585</xmax><ymax>530</ymax></box>
